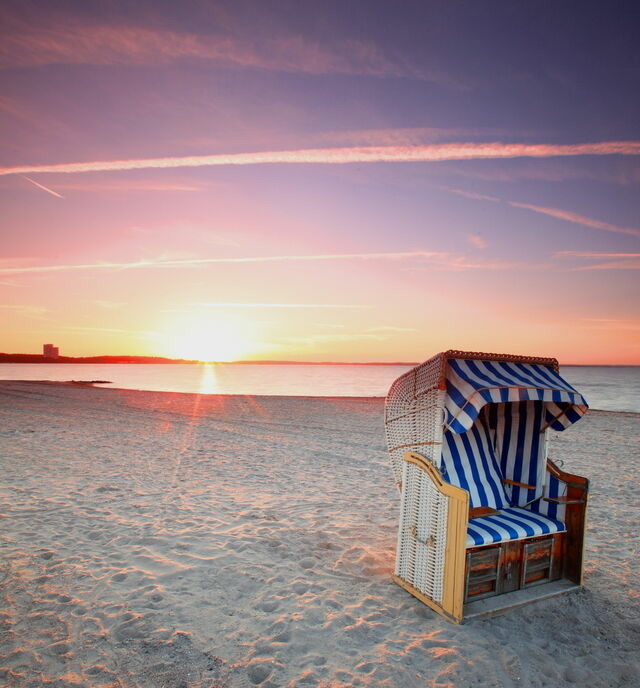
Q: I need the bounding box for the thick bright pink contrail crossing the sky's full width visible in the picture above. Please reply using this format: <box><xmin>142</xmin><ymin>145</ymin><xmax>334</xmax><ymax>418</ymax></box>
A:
<box><xmin>0</xmin><ymin>141</ymin><xmax>640</xmax><ymax>175</ymax></box>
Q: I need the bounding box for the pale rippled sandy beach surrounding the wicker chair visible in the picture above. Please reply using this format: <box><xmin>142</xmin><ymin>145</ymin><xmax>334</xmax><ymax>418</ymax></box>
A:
<box><xmin>0</xmin><ymin>381</ymin><xmax>640</xmax><ymax>688</ymax></box>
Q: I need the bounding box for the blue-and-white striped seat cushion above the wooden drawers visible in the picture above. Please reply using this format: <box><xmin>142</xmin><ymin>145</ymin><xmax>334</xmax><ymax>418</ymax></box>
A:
<box><xmin>467</xmin><ymin>507</ymin><xmax>566</xmax><ymax>547</ymax></box>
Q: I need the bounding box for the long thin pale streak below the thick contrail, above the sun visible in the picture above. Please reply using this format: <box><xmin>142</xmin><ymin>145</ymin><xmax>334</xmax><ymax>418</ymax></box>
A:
<box><xmin>0</xmin><ymin>250</ymin><xmax>540</xmax><ymax>274</ymax></box>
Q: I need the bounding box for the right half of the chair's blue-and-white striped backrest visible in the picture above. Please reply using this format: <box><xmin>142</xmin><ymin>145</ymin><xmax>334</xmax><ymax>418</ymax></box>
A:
<box><xmin>481</xmin><ymin>401</ymin><xmax>546</xmax><ymax>506</ymax></box>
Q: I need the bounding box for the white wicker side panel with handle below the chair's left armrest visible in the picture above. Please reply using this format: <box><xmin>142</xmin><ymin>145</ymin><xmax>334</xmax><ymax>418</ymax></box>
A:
<box><xmin>395</xmin><ymin>463</ymin><xmax>448</xmax><ymax>604</ymax></box>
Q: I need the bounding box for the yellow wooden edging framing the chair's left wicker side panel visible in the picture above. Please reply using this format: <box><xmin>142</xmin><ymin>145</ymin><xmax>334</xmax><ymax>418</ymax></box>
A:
<box><xmin>403</xmin><ymin>452</ymin><xmax>469</xmax><ymax>623</ymax></box>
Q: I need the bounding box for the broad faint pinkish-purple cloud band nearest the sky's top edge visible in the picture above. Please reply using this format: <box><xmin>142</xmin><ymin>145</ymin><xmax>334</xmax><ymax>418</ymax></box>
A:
<box><xmin>0</xmin><ymin>17</ymin><xmax>430</xmax><ymax>81</ymax></box>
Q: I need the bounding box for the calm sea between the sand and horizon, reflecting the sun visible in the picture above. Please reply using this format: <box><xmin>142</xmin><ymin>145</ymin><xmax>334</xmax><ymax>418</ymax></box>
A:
<box><xmin>0</xmin><ymin>363</ymin><xmax>640</xmax><ymax>413</ymax></box>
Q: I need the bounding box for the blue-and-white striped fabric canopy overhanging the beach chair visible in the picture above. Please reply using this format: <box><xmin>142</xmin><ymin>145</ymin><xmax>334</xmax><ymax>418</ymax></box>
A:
<box><xmin>445</xmin><ymin>359</ymin><xmax>588</xmax><ymax>433</ymax></box>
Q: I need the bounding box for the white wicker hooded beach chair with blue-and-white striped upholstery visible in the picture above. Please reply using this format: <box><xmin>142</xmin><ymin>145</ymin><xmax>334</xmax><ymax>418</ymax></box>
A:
<box><xmin>385</xmin><ymin>350</ymin><xmax>588</xmax><ymax>623</ymax></box>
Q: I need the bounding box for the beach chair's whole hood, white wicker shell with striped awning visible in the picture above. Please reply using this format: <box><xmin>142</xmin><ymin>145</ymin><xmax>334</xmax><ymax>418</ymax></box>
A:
<box><xmin>385</xmin><ymin>350</ymin><xmax>588</xmax><ymax>483</ymax></box>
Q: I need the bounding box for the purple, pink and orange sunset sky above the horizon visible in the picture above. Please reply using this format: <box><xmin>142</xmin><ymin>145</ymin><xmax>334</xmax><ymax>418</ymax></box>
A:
<box><xmin>0</xmin><ymin>0</ymin><xmax>640</xmax><ymax>364</ymax></box>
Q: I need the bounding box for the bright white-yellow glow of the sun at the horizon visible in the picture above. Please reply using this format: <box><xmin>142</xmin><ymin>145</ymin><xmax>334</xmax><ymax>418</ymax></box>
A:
<box><xmin>162</xmin><ymin>313</ymin><xmax>254</xmax><ymax>361</ymax></box>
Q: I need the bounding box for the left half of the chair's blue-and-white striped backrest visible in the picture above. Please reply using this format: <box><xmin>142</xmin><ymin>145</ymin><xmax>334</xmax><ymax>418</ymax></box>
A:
<box><xmin>441</xmin><ymin>408</ymin><xmax>509</xmax><ymax>509</ymax></box>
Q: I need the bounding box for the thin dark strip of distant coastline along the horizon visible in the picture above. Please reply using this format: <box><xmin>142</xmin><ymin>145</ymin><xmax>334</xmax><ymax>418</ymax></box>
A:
<box><xmin>0</xmin><ymin>353</ymin><xmax>418</xmax><ymax>366</ymax></box>
